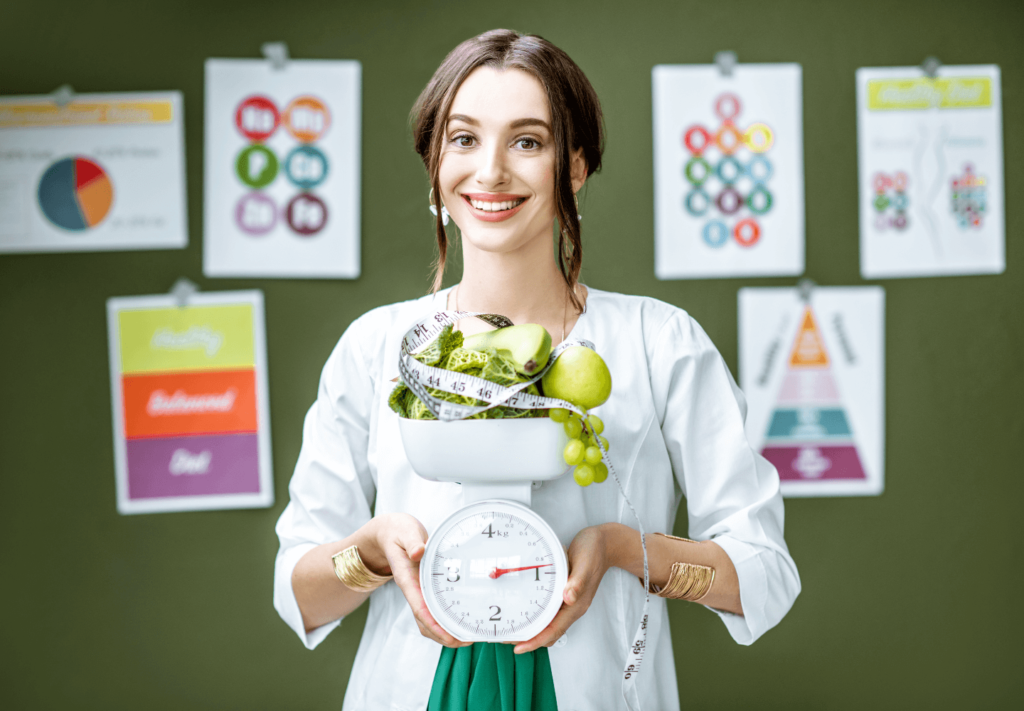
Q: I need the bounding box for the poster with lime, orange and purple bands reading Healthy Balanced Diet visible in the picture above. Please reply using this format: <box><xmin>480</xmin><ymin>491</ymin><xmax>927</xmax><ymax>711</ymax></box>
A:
<box><xmin>106</xmin><ymin>291</ymin><xmax>273</xmax><ymax>513</ymax></box>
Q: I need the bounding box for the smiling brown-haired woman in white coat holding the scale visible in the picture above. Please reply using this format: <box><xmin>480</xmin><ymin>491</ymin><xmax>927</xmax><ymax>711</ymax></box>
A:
<box><xmin>274</xmin><ymin>30</ymin><xmax>800</xmax><ymax>711</ymax></box>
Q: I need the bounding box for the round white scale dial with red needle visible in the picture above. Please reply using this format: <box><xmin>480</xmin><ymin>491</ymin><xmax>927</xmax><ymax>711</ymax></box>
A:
<box><xmin>420</xmin><ymin>499</ymin><xmax>568</xmax><ymax>642</ymax></box>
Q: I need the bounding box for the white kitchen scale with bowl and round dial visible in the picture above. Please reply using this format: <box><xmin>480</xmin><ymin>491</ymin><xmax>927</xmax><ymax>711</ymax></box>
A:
<box><xmin>398</xmin><ymin>417</ymin><xmax>570</xmax><ymax>642</ymax></box>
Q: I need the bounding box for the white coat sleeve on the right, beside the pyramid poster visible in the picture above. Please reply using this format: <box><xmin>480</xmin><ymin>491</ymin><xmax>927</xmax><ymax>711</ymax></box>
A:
<box><xmin>651</xmin><ymin>311</ymin><xmax>800</xmax><ymax>644</ymax></box>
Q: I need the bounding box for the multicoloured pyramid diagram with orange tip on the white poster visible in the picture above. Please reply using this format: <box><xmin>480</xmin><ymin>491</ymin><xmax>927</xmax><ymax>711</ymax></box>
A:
<box><xmin>761</xmin><ymin>305</ymin><xmax>867</xmax><ymax>482</ymax></box>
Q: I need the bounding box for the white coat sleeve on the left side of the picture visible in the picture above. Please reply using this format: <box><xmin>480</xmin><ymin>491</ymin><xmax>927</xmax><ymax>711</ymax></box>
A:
<box><xmin>273</xmin><ymin>317</ymin><xmax>376</xmax><ymax>650</ymax></box>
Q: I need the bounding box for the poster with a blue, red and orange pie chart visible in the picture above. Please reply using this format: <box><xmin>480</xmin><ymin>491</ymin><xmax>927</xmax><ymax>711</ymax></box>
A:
<box><xmin>0</xmin><ymin>91</ymin><xmax>188</xmax><ymax>253</ymax></box>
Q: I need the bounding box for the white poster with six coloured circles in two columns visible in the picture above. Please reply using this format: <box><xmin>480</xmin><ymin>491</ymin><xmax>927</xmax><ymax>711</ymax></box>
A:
<box><xmin>203</xmin><ymin>59</ymin><xmax>360</xmax><ymax>279</ymax></box>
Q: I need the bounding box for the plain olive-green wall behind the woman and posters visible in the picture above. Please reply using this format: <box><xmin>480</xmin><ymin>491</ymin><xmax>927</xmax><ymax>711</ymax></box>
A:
<box><xmin>0</xmin><ymin>0</ymin><xmax>1024</xmax><ymax>709</ymax></box>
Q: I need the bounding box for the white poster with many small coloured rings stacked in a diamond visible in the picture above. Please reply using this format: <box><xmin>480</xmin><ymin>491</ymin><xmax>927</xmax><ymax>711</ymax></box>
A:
<box><xmin>652</xmin><ymin>64</ymin><xmax>804</xmax><ymax>279</ymax></box>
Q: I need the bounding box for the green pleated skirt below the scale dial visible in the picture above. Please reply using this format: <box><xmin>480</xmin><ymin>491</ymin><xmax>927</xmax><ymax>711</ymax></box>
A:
<box><xmin>427</xmin><ymin>642</ymin><xmax>558</xmax><ymax>711</ymax></box>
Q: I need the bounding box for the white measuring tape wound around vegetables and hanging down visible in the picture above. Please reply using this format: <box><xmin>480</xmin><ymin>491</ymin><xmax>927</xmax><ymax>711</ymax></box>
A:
<box><xmin>398</xmin><ymin>311</ymin><xmax>650</xmax><ymax>711</ymax></box>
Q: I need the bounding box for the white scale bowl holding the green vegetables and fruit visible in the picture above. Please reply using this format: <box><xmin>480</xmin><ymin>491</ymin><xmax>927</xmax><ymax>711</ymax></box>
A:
<box><xmin>398</xmin><ymin>417</ymin><xmax>569</xmax><ymax>483</ymax></box>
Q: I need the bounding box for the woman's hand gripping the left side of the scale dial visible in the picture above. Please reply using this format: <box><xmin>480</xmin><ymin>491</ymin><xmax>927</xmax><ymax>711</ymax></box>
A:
<box><xmin>373</xmin><ymin>513</ymin><xmax>469</xmax><ymax>646</ymax></box>
